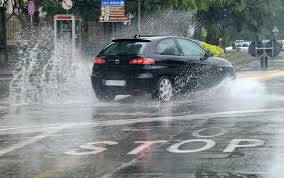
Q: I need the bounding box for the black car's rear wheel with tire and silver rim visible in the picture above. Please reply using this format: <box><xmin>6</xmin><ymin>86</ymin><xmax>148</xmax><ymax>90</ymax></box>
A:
<box><xmin>152</xmin><ymin>77</ymin><xmax>173</xmax><ymax>102</ymax></box>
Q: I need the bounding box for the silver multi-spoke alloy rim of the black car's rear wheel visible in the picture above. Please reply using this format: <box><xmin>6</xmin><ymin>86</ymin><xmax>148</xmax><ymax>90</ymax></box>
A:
<box><xmin>159</xmin><ymin>78</ymin><xmax>173</xmax><ymax>101</ymax></box>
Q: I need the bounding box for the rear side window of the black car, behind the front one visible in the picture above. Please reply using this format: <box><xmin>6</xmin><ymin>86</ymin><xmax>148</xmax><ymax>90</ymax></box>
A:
<box><xmin>156</xmin><ymin>39</ymin><xmax>180</xmax><ymax>55</ymax></box>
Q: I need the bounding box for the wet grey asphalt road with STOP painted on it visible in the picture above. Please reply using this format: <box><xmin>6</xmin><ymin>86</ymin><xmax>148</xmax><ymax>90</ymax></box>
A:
<box><xmin>0</xmin><ymin>57</ymin><xmax>284</xmax><ymax>178</ymax></box>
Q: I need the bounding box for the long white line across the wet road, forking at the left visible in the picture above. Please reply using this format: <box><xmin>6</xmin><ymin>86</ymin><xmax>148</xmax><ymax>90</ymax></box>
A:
<box><xmin>0</xmin><ymin>108</ymin><xmax>284</xmax><ymax>156</ymax></box>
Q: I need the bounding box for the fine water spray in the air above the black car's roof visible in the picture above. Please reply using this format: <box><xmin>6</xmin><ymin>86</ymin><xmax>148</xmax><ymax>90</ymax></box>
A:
<box><xmin>83</xmin><ymin>10</ymin><xmax>197</xmax><ymax>55</ymax></box>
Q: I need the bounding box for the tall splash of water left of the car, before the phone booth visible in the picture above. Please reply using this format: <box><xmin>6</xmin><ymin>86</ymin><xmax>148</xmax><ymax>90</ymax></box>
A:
<box><xmin>9</xmin><ymin>28</ymin><xmax>94</xmax><ymax>104</ymax></box>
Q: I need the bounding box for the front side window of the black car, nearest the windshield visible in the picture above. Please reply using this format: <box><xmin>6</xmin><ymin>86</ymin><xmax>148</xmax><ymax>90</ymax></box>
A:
<box><xmin>177</xmin><ymin>39</ymin><xmax>205</xmax><ymax>57</ymax></box>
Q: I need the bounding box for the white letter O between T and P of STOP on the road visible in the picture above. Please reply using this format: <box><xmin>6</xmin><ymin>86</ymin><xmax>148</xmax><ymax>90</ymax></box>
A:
<box><xmin>167</xmin><ymin>139</ymin><xmax>216</xmax><ymax>153</ymax></box>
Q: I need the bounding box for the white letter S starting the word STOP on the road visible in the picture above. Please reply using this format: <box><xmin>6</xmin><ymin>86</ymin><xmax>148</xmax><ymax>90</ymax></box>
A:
<box><xmin>65</xmin><ymin>141</ymin><xmax>118</xmax><ymax>156</ymax></box>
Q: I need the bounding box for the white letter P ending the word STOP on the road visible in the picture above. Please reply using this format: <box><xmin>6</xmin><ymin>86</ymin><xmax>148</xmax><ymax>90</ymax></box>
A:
<box><xmin>223</xmin><ymin>139</ymin><xmax>264</xmax><ymax>153</ymax></box>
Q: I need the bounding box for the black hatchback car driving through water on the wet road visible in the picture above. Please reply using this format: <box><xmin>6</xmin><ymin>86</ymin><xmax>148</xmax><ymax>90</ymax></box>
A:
<box><xmin>91</xmin><ymin>36</ymin><xmax>235</xmax><ymax>101</ymax></box>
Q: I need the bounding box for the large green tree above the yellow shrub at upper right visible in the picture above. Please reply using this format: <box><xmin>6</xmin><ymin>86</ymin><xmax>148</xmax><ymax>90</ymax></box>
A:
<box><xmin>196</xmin><ymin>0</ymin><xmax>283</xmax><ymax>44</ymax></box>
